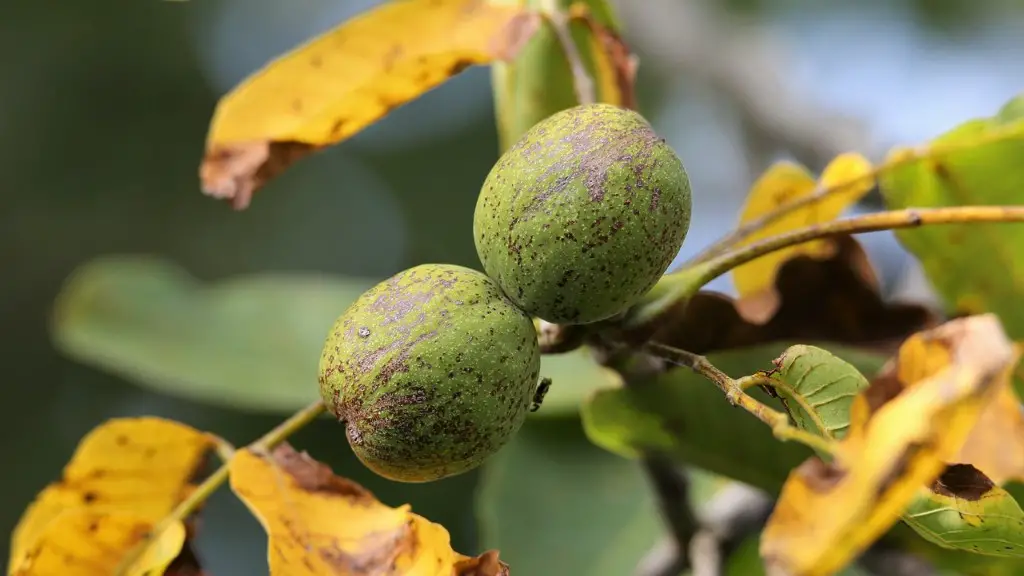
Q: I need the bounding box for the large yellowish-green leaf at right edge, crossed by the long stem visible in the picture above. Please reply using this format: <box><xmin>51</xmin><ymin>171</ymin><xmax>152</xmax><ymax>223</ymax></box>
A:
<box><xmin>880</xmin><ymin>90</ymin><xmax>1024</xmax><ymax>339</ymax></box>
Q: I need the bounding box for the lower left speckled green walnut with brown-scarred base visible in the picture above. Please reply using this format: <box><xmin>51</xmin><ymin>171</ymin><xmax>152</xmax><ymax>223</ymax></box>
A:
<box><xmin>319</xmin><ymin>264</ymin><xmax>541</xmax><ymax>482</ymax></box>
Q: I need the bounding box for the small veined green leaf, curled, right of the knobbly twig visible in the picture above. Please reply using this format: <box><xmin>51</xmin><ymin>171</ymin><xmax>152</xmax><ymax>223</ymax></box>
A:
<box><xmin>773</xmin><ymin>344</ymin><xmax>867</xmax><ymax>440</ymax></box>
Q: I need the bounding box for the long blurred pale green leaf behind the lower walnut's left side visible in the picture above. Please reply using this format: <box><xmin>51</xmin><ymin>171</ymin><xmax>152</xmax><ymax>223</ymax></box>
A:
<box><xmin>52</xmin><ymin>257</ymin><xmax>376</xmax><ymax>412</ymax></box>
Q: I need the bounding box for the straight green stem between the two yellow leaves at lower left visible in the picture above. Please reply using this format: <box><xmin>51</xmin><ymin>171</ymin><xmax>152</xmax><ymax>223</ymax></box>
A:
<box><xmin>115</xmin><ymin>400</ymin><xmax>327</xmax><ymax>576</ymax></box>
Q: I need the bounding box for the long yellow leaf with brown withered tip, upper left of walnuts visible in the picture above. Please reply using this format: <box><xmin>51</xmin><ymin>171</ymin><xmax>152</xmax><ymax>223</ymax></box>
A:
<box><xmin>200</xmin><ymin>0</ymin><xmax>538</xmax><ymax>208</ymax></box>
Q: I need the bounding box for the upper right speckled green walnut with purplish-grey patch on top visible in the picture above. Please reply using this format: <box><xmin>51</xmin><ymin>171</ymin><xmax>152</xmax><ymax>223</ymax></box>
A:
<box><xmin>473</xmin><ymin>104</ymin><xmax>691</xmax><ymax>324</ymax></box>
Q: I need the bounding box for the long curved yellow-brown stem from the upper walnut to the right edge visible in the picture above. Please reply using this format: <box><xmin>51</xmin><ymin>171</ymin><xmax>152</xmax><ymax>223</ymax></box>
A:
<box><xmin>629</xmin><ymin>206</ymin><xmax>1024</xmax><ymax>326</ymax></box>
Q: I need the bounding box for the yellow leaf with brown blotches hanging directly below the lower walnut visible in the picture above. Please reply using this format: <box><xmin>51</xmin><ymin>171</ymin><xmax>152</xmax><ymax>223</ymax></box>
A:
<box><xmin>230</xmin><ymin>444</ymin><xmax>507</xmax><ymax>576</ymax></box>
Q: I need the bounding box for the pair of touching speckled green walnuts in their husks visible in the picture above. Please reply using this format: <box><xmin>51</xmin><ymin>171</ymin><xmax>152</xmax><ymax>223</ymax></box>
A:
<box><xmin>319</xmin><ymin>104</ymin><xmax>691</xmax><ymax>482</ymax></box>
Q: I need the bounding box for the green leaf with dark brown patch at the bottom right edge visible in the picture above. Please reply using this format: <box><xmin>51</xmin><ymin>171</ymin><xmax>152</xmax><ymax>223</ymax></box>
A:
<box><xmin>903</xmin><ymin>464</ymin><xmax>1024</xmax><ymax>559</ymax></box>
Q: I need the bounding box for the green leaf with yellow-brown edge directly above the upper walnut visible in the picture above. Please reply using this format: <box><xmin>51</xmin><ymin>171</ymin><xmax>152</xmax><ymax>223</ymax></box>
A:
<box><xmin>492</xmin><ymin>0</ymin><xmax>636</xmax><ymax>151</ymax></box>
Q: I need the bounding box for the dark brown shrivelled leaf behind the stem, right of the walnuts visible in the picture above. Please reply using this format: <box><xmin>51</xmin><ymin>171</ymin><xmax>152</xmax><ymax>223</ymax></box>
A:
<box><xmin>660</xmin><ymin>237</ymin><xmax>937</xmax><ymax>354</ymax></box>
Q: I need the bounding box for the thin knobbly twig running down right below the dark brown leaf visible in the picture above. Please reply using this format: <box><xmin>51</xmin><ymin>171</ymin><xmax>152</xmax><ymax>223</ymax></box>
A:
<box><xmin>646</xmin><ymin>342</ymin><xmax>835</xmax><ymax>454</ymax></box>
